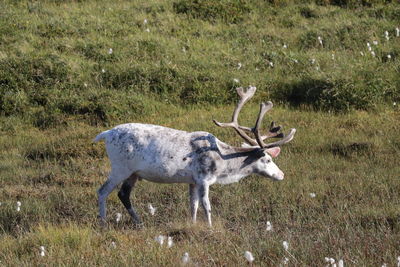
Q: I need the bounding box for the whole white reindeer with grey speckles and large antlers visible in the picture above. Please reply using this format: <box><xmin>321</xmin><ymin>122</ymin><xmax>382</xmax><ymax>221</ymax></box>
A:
<box><xmin>94</xmin><ymin>87</ymin><xmax>296</xmax><ymax>226</ymax></box>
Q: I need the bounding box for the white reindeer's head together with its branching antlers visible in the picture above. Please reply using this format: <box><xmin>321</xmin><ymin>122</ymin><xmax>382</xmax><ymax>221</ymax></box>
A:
<box><xmin>213</xmin><ymin>86</ymin><xmax>296</xmax><ymax>180</ymax></box>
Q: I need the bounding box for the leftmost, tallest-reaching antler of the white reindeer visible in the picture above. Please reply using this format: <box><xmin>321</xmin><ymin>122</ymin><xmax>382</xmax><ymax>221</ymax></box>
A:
<box><xmin>213</xmin><ymin>86</ymin><xmax>257</xmax><ymax>146</ymax></box>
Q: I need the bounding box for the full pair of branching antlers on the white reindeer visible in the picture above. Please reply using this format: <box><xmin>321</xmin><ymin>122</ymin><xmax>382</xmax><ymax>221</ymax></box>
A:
<box><xmin>213</xmin><ymin>86</ymin><xmax>296</xmax><ymax>148</ymax></box>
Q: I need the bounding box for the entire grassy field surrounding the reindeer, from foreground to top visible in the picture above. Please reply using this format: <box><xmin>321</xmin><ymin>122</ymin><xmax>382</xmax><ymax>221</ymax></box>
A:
<box><xmin>0</xmin><ymin>0</ymin><xmax>400</xmax><ymax>266</ymax></box>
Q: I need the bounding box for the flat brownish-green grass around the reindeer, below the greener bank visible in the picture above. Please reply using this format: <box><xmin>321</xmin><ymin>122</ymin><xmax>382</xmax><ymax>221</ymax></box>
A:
<box><xmin>0</xmin><ymin>107</ymin><xmax>400</xmax><ymax>266</ymax></box>
